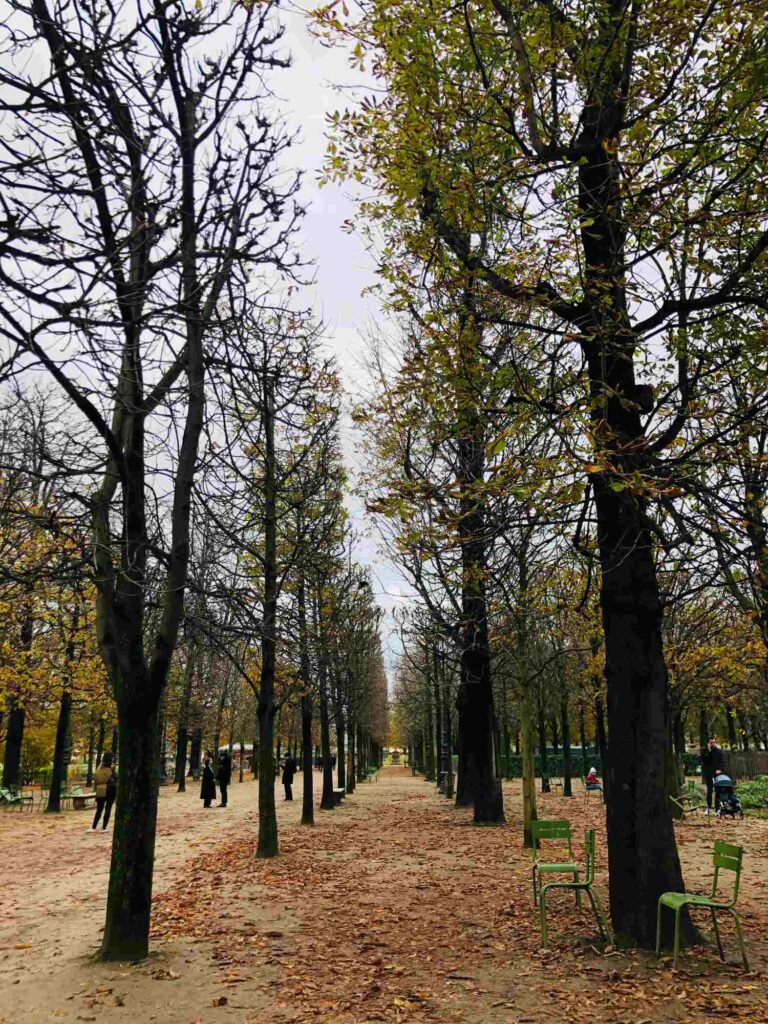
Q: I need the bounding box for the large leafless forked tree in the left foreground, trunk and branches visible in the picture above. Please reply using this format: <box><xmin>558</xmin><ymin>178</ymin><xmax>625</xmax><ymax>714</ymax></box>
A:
<box><xmin>0</xmin><ymin>0</ymin><xmax>299</xmax><ymax>959</ymax></box>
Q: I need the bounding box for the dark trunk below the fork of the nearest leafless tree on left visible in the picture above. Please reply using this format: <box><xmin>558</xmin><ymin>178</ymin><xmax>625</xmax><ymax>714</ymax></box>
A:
<box><xmin>99</xmin><ymin>700</ymin><xmax>158</xmax><ymax>961</ymax></box>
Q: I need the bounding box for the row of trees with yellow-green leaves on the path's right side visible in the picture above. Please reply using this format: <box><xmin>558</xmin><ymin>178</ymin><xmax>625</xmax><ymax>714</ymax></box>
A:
<box><xmin>317</xmin><ymin>0</ymin><xmax>768</xmax><ymax>945</ymax></box>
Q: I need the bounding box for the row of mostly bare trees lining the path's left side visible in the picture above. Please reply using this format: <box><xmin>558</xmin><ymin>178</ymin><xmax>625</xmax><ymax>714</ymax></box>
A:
<box><xmin>0</xmin><ymin>0</ymin><xmax>383</xmax><ymax>959</ymax></box>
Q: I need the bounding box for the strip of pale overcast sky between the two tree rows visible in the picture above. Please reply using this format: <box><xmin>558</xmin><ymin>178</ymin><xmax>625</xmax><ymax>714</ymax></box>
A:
<box><xmin>272</xmin><ymin>6</ymin><xmax>409</xmax><ymax>664</ymax></box>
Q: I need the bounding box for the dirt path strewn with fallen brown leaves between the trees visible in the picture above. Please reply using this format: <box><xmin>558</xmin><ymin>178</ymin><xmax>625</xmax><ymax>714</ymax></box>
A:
<box><xmin>0</xmin><ymin>768</ymin><xmax>768</xmax><ymax>1024</ymax></box>
